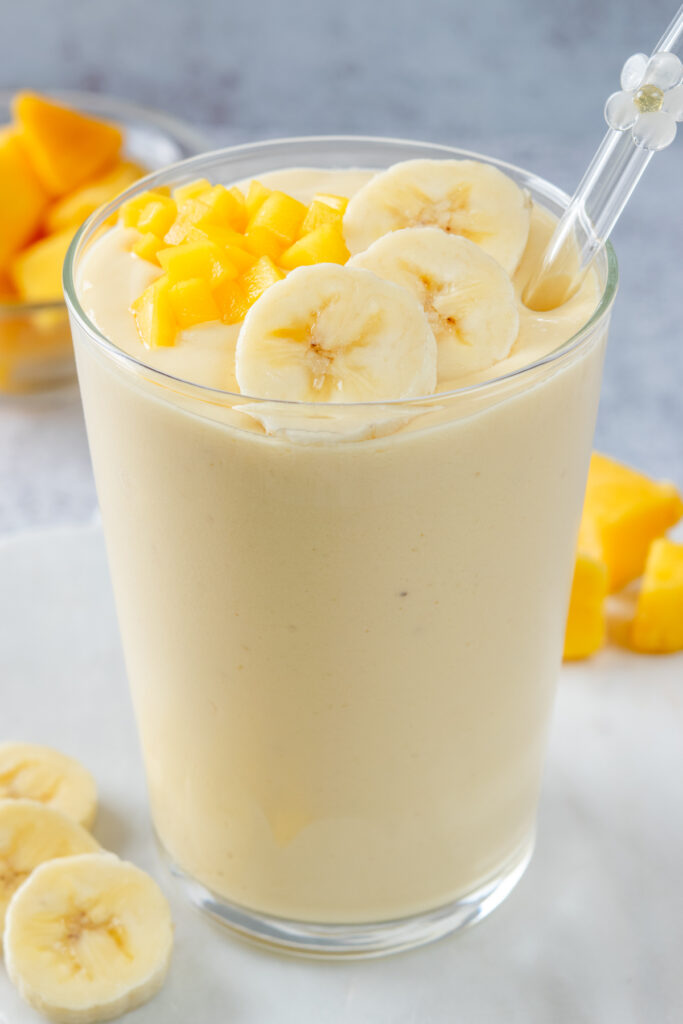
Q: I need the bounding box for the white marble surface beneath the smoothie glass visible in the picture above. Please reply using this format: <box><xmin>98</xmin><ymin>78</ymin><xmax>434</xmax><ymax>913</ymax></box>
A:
<box><xmin>0</xmin><ymin>526</ymin><xmax>683</xmax><ymax>1024</ymax></box>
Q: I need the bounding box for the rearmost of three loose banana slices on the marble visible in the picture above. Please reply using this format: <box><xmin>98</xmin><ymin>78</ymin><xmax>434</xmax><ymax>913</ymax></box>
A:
<box><xmin>0</xmin><ymin>743</ymin><xmax>97</xmax><ymax>828</ymax></box>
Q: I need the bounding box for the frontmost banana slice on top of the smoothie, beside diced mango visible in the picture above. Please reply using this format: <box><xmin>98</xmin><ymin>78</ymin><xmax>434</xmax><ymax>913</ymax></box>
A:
<box><xmin>236</xmin><ymin>263</ymin><xmax>436</xmax><ymax>402</ymax></box>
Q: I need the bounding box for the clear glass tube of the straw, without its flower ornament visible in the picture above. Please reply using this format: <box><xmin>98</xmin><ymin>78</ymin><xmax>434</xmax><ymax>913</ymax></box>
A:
<box><xmin>523</xmin><ymin>6</ymin><xmax>683</xmax><ymax>310</ymax></box>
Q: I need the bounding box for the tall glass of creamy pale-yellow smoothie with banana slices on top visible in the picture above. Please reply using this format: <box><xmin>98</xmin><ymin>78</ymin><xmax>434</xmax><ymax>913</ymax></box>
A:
<box><xmin>65</xmin><ymin>137</ymin><xmax>616</xmax><ymax>956</ymax></box>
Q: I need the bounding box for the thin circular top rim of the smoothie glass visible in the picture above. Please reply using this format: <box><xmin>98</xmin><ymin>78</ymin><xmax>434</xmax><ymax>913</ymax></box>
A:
<box><xmin>62</xmin><ymin>135</ymin><xmax>618</xmax><ymax>415</ymax></box>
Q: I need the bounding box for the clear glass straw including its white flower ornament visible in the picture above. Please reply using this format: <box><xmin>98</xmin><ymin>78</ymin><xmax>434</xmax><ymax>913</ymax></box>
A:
<box><xmin>523</xmin><ymin>6</ymin><xmax>683</xmax><ymax>310</ymax></box>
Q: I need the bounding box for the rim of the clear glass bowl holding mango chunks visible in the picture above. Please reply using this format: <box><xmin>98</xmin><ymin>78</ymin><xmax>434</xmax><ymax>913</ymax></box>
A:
<box><xmin>0</xmin><ymin>89</ymin><xmax>211</xmax><ymax>319</ymax></box>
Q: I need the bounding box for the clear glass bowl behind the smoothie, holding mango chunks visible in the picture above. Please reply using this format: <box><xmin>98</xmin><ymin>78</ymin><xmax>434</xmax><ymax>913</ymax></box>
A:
<box><xmin>0</xmin><ymin>91</ymin><xmax>209</xmax><ymax>393</ymax></box>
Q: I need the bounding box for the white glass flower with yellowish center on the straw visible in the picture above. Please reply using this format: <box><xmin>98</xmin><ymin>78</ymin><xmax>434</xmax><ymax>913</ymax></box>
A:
<box><xmin>605</xmin><ymin>50</ymin><xmax>683</xmax><ymax>150</ymax></box>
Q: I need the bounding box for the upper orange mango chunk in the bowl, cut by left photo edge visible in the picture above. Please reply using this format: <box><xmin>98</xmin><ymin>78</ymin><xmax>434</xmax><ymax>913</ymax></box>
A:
<box><xmin>0</xmin><ymin>128</ymin><xmax>48</xmax><ymax>270</ymax></box>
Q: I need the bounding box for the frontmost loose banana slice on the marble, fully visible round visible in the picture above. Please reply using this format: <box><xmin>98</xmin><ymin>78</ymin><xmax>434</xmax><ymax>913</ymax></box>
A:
<box><xmin>5</xmin><ymin>853</ymin><xmax>173</xmax><ymax>1024</ymax></box>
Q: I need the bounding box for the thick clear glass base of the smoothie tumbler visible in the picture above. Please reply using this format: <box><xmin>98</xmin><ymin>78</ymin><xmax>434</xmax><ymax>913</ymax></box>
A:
<box><xmin>160</xmin><ymin>836</ymin><xmax>535</xmax><ymax>959</ymax></box>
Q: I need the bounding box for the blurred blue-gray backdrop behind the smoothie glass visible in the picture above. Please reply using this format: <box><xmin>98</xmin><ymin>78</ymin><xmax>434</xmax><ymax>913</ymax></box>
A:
<box><xmin>0</xmin><ymin>0</ymin><xmax>683</xmax><ymax>532</ymax></box>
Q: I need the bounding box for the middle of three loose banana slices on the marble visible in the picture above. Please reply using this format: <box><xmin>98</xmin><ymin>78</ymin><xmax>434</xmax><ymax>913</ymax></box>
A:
<box><xmin>0</xmin><ymin>800</ymin><xmax>99</xmax><ymax>938</ymax></box>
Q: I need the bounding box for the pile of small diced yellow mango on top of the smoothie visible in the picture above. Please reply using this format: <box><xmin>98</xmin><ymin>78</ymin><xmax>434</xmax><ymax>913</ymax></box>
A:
<box><xmin>124</xmin><ymin>178</ymin><xmax>349</xmax><ymax>346</ymax></box>
